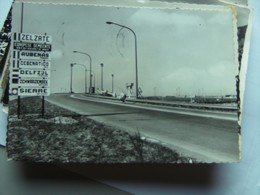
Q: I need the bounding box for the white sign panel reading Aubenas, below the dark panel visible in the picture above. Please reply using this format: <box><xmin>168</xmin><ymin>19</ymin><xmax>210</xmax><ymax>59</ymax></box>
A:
<box><xmin>12</xmin><ymin>51</ymin><xmax>51</xmax><ymax>60</ymax></box>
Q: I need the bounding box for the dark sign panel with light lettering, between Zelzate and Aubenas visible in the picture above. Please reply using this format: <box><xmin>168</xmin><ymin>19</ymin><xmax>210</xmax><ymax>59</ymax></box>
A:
<box><xmin>13</xmin><ymin>42</ymin><xmax>51</xmax><ymax>52</ymax></box>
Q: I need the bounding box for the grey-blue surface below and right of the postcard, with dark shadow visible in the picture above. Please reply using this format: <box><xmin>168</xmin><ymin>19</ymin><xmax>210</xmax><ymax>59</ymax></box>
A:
<box><xmin>0</xmin><ymin>0</ymin><xmax>260</xmax><ymax>195</ymax></box>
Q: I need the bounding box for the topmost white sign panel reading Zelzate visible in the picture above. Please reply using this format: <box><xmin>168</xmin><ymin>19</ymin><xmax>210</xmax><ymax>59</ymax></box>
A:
<box><xmin>13</xmin><ymin>33</ymin><xmax>52</xmax><ymax>44</ymax></box>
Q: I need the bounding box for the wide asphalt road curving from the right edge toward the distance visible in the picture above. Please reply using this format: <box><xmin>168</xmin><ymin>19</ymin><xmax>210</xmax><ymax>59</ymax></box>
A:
<box><xmin>46</xmin><ymin>94</ymin><xmax>239</xmax><ymax>162</ymax></box>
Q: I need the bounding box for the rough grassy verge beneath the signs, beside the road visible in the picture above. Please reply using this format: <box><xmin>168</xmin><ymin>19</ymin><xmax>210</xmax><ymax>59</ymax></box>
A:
<box><xmin>7</xmin><ymin>97</ymin><xmax>194</xmax><ymax>163</ymax></box>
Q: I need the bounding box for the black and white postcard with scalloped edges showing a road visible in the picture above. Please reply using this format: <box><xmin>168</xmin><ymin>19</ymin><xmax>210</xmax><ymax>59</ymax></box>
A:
<box><xmin>7</xmin><ymin>2</ymin><xmax>241</xmax><ymax>164</ymax></box>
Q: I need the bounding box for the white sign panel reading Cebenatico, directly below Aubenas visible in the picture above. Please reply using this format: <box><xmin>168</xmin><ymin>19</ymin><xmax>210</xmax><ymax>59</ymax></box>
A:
<box><xmin>13</xmin><ymin>60</ymin><xmax>51</xmax><ymax>69</ymax></box>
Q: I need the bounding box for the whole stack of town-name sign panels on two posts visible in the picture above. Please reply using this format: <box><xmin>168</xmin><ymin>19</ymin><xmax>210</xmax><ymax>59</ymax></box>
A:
<box><xmin>10</xmin><ymin>33</ymin><xmax>52</xmax><ymax>115</ymax></box>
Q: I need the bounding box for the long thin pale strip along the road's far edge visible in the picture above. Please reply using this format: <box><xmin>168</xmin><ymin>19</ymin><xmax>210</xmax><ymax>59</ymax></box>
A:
<box><xmin>70</xmin><ymin>94</ymin><xmax>238</xmax><ymax>121</ymax></box>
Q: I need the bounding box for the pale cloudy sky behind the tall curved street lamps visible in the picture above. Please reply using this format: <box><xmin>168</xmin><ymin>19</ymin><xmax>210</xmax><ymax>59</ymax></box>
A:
<box><xmin>13</xmin><ymin>3</ymin><xmax>236</xmax><ymax>96</ymax></box>
